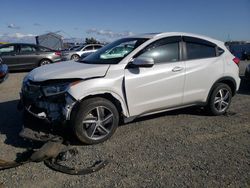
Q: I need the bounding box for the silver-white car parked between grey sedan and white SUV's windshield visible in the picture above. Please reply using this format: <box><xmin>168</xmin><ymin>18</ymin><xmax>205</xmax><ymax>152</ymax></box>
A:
<box><xmin>63</xmin><ymin>44</ymin><xmax>103</xmax><ymax>61</ymax></box>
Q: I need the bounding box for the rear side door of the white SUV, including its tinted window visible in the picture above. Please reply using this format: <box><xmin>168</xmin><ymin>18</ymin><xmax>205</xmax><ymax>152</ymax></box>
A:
<box><xmin>183</xmin><ymin>36</ymin><xmax>223</xmax><ymax>104</ymax></box>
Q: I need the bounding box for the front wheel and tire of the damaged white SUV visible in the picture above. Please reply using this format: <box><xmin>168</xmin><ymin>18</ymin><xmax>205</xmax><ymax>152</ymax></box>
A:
<box><xmin>71</xmin><ymin>97</ymin><xmax>119</xmax><ymax>144</ymax></box>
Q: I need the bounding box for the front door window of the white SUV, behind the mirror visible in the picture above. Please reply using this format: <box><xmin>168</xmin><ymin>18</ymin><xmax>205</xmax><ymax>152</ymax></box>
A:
<box><xmin>137</xmin><ymin>37</ymin><xmax>180</xmax><ymax>64</ymax></box>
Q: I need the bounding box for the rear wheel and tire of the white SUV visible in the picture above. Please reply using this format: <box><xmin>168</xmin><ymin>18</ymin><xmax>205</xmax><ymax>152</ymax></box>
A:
<box><xmin>207</xmin><ymin>83</ymin><xmax>232</xmax><ymax>116</ymax></box>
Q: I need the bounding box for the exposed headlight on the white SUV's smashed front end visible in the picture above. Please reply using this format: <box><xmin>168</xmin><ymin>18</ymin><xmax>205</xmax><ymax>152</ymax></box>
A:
<box><xmin>42</xmin><ymin>83</ymin><xmax>70</xmax><ymax>96</ymax></box>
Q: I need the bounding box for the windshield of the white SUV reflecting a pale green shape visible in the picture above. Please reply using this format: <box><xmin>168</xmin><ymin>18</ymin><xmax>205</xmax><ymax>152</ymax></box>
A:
<box><xmin>80</xmin><ymin>38</ymin><xmax>148</xmax><ymax>64</ymax></box>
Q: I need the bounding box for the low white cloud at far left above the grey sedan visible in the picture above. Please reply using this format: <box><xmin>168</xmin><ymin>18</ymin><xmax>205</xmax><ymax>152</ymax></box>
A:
<box><xmin>0</xmin><ymin>33</ymin><xmax>36</xmax><ymax>42</ymax></box>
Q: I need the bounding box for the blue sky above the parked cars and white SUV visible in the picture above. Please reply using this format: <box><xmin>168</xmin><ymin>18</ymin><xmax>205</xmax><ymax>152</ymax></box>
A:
<box><xmin>0</xmin><ymin>0</ymin><xmax>250</xmax><ymax>42</ymax></box>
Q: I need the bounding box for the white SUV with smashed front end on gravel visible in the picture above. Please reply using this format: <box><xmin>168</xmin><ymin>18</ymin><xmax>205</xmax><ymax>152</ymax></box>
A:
<box><xmin>21</xmin><ymin>32</ymin><xmax>240</xmax><ymax>144</ymax></box>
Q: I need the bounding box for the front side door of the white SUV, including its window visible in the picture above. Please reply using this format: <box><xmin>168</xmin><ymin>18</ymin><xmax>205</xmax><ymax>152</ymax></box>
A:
<box><xmin>125</xmin><ymin>36</ymin><xmax>185</xmax><ymax>116</ymax></box>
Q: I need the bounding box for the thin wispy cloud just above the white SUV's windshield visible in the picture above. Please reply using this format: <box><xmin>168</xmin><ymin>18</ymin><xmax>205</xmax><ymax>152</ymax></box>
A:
<box><xmin>86</xmin><ymin>28</ymin><xmax>134</xmax><ymax>38</ymax></box>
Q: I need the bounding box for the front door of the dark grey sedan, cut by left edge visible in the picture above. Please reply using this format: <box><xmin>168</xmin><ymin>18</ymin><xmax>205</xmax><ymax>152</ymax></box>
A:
<box><xmin>0</xmin><ymin>44</ymin><xmax>18</xmax><ymax>70</ymax></box>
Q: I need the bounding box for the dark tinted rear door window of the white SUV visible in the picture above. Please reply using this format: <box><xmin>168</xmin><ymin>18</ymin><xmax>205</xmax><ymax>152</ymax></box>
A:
<box><xmin>184</xmin><ymin>37</ymin><xmax>217</xmax><ymax>59</ymax></box>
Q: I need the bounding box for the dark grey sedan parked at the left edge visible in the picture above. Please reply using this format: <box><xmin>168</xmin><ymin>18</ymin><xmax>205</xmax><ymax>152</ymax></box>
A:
<box><xmin>0</xmin><ymin>43</ymin><xmax>62</xmax><ymax>70</ymax></box>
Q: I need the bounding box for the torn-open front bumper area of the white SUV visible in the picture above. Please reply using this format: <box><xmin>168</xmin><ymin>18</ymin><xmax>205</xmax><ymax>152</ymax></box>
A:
<box><xmin>18</xmin><ymin>81</ymin><xmax>77</xmax><ymax>141</ymax></box>
